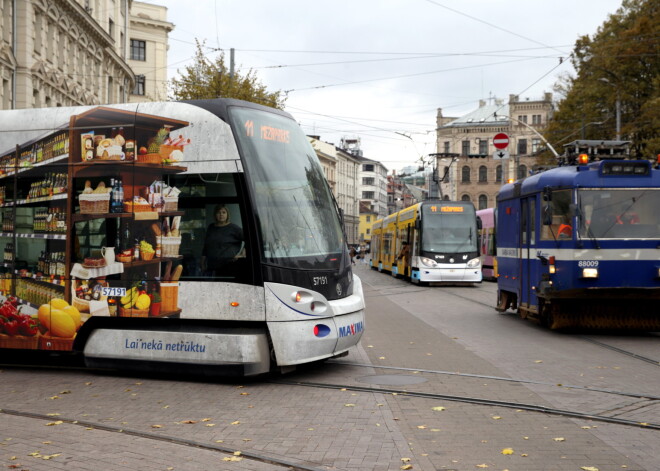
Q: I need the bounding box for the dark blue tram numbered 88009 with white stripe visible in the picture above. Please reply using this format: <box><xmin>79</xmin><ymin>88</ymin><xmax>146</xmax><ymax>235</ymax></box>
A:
<box><xmin>497</xmin><ymin>148</ymin><xmax>660</xmax><ymax>331</ymax></box>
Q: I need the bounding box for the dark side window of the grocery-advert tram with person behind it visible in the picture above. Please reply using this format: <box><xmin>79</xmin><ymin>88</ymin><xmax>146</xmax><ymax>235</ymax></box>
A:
<box><xmin>170</xmin><ymin>174</ymin><xmax>251</xmax><ymax>282</ymax></box>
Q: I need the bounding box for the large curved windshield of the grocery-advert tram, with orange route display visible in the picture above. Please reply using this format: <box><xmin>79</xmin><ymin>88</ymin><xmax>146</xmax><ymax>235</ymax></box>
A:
<box><xmin>230</xmin><ymin>107</ymin><xmax>345</xmax><ymax>268</ymax></box>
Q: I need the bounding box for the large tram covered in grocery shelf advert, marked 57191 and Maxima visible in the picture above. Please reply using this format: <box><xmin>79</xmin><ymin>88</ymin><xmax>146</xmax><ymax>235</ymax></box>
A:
<box><xmin>0</xmin><ymin>99</ymin><xmax>365</xmax><ymax>375</ymax></box>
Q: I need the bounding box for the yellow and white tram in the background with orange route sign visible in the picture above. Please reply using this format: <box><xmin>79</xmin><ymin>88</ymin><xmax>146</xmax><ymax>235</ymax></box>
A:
<box><xmin>370</xmin><ymin>200</ymin><xmax>482</xmax><ymax>284</ymax></box>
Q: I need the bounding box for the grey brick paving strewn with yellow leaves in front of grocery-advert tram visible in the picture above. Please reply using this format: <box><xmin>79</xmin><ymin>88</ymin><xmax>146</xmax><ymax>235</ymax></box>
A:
<box><xmin>0</xmin><ymin>266</ymin><xmax>660</xmax><ymax>471</ymax></box>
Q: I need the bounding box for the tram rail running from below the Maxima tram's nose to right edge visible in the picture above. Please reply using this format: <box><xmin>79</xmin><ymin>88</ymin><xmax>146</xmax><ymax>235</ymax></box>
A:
<box><xmin>271</xmin><ymin>380</ymin><xmax>660</xmax><ymax>430</ymax></box>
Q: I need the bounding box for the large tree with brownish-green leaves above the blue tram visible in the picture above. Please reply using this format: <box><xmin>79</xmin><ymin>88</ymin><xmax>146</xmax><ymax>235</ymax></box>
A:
<box><xmin>548</xmin><ymin>0</ymin><xmax>660</xmax><ymax>158</ymax></box>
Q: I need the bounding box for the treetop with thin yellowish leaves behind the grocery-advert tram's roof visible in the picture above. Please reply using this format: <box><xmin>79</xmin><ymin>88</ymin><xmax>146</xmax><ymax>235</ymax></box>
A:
<box><xmin>170</xmin><ymin>41</ymin><xmax>286</xmax><ymax>109</ymax></box>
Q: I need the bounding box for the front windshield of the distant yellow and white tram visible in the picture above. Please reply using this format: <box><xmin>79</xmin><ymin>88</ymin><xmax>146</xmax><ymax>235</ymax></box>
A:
<box><xmin>422</xmin><ymin>205</ymin><xmax>478</xmax><ymax>253</ymax></box>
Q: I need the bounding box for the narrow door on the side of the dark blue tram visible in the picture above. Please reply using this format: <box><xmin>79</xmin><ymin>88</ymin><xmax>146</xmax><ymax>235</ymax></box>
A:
<box><xmin>520</xmin><ymin>196</ymin><xmax>537</xmax><ymax>309</ymax></box>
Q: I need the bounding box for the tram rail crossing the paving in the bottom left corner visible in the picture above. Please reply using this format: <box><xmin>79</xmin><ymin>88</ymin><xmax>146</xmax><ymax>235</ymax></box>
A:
<box><xmin>0</xmin><ymin>408</ymin><xmax>325</xmax><ymax>471</ymax></box>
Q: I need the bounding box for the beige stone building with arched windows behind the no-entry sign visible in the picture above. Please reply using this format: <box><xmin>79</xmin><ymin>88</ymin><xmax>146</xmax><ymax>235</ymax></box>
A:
<box><xmin>436</xmin><ymin>93</ymin><xmax>553</xmax><ymax>209</ymax></box>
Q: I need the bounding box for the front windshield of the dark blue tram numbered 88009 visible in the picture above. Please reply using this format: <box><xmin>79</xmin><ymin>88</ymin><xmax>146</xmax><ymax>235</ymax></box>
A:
<box><xmin>577</xmin><ymin>188</ymin><xmax>660</xmax><ymax>239</ymax></box>
